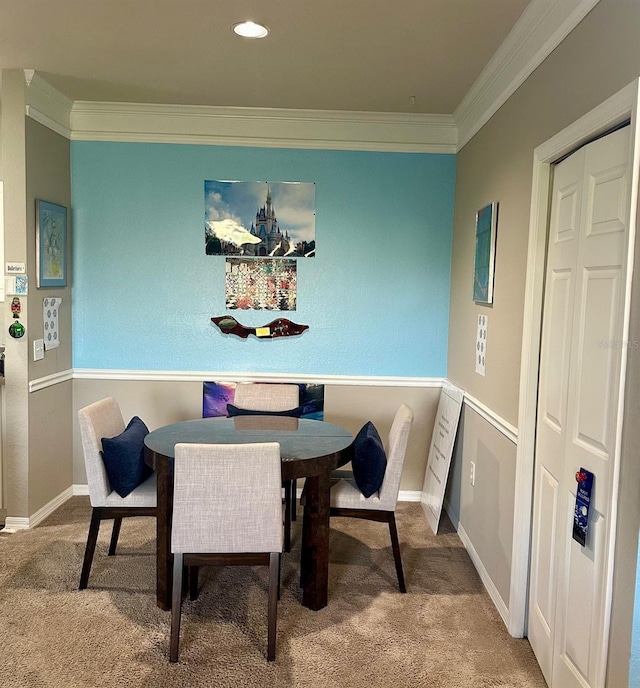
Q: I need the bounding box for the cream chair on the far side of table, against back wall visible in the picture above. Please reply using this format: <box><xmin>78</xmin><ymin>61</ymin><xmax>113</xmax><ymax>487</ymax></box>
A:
<box><xmin>233</xmin><ymin>382</ymin><xmax>302</xmax><ymax>552</ymax></box>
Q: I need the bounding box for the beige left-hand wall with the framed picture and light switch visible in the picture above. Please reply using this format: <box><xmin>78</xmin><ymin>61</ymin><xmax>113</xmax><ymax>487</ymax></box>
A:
<box><xmin>2</xmin><ymin>70</ymin><xmax>73</xmax><ymax>518</ymax></box>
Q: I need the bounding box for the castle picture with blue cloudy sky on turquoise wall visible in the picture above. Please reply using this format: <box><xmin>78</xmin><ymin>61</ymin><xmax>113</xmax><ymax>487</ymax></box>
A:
<box><xmin>205</xmin><ymin>181</ymin><xmax>316</xmax><ymax>258</ymax></box>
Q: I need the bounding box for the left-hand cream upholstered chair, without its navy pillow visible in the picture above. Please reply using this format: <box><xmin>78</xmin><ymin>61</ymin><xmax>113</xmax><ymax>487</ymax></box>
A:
<box><xmin>78</xmin><ymin>397</ymin><xmax>157</xmax><ymax>590</ymax></box>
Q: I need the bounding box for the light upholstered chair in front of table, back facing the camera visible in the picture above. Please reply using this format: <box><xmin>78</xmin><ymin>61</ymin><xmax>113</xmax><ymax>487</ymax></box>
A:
<box><xmin>169</xmin><ymin>442</ymin><xmax>283</xmax><ymax>662</ymax></box>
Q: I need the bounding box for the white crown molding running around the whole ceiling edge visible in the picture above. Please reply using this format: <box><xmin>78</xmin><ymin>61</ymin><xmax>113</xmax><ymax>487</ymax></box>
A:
<box><xmin>18</xmin><ymin>0</ymin><xmax>599</xmax><ymax>153</ymax></box>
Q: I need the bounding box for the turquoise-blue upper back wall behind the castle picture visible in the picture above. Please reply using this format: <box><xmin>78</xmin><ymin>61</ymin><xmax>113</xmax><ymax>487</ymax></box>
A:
<box><xmin>71</xmin><ymin>141</ymin><xmax>456</xmax><ymax>377</ymax></box>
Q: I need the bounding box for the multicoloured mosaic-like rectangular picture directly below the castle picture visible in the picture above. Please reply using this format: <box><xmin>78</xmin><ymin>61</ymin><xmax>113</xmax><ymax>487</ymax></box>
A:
<box><xmin>225</xmin><ymin>258</ymin><xmax>298</xmax><ymax>311</ymax></box>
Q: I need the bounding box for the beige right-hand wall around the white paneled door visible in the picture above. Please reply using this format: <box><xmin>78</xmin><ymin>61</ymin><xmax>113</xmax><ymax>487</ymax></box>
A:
<box><xmin>448</xmin><ymin>0</ymin><xmax>640</xmax><ymax>685</ymax></box>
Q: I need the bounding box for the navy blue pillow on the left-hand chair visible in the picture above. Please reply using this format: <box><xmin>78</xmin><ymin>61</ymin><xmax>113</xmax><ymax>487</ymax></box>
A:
<box><xmin>102</xmin><ymin>416</ymin><xmax>152</xmax><ymax>497</ymax></box>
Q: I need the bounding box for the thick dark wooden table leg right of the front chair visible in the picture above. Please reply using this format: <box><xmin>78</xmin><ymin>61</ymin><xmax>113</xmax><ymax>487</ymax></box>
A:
<box><xmin>300</xmin><ymin>467</ymin><xmax>330</xmax><ymax>611</ymax></box>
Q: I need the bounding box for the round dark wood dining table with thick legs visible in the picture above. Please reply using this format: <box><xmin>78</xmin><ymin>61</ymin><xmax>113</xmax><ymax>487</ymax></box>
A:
<box><xmin>144</xmin><ymin>415</ymin><xmax>353</xmax><ymax>610</ymax></box>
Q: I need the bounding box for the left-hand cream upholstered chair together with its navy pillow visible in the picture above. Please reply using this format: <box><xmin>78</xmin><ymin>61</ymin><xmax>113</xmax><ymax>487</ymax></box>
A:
<box><xmin>78</xmin><ymin>397</ymin><xmax>157</xmax><ymax>590</ymax></box>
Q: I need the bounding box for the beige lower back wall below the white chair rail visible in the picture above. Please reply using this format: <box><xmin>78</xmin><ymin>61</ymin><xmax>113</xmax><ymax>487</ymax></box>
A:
<box><xmin>73</xmin><ymin>379</ymin><xmax>440</xmax><ymax>491</ymax></box>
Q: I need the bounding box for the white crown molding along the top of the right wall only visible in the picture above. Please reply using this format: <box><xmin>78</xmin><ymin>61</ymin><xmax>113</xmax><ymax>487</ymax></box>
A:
<box><xmin>453</xmin><ymin>0</ymin><xmax>600</xmax><ymax>150</ymax></box>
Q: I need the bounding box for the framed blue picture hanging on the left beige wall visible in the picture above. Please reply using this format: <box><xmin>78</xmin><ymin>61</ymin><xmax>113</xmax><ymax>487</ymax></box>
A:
<box><xmin>36</xmin><ymin>200</ymin><xmax>67</xmax><ymax>288</ymax></box>
